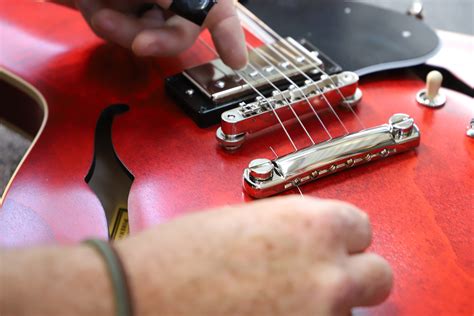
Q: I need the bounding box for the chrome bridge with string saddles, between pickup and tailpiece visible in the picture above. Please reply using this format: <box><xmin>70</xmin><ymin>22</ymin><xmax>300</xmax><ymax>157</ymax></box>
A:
<box><xmin>216</xmin><ymin>72</ymin><xmax>362</xmax><ymax>150</ymax></box>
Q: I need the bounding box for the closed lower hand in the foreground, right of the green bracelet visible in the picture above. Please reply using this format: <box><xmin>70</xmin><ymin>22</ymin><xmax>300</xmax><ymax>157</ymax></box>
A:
<box><xmin>116</xmin><ymin>197</ymin><xmax>392</xmax><ymax>316</ymax></box>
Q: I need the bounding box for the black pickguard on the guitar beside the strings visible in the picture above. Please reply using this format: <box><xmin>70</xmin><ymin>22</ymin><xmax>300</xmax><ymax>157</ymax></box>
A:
<box><xmin>246</xmin><ymin>0</ymin><xmax>439</xmax><ymax>75</ymax></box>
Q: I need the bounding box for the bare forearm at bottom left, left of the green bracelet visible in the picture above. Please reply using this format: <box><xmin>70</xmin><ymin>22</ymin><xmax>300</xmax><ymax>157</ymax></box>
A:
<box><xmin>0</xmin><ymin>246</ymin><xmax>114</xmax><ymax>316</ymax></box>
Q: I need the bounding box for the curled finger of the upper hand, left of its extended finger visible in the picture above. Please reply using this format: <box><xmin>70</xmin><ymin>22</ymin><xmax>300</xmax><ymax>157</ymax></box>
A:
<box><xmin>132</xmin><ymin>15</ymin><xmax>200</xmax><ymax>56</ymax></box>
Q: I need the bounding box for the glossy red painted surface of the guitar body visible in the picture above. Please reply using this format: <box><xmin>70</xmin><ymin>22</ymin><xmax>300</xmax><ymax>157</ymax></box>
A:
<box><xmin>0</xmin><ymin>0</ymin><xmax>474</xmax><ymax>315</ymax></box>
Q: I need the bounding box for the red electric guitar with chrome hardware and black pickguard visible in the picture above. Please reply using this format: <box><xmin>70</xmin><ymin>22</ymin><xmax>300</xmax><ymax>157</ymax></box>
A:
<box><xmin>0</xmin><ymin>0</ymin><xmax>474</xmax><ymax>315</ymax></box>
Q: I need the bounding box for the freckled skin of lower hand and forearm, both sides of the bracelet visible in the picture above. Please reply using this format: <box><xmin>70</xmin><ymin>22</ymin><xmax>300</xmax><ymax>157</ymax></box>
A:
<box><xmin>0</xmin><ymin>197</ymin><xmax>392</xmax><ymax>316</ymax></box>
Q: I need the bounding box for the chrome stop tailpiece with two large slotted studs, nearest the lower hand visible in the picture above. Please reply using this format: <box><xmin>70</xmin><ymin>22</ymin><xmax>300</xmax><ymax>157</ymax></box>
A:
<box><xmin>243</xmin><ymin>114</ymin><xmax>420</xmax><ymax>198</ymax></box>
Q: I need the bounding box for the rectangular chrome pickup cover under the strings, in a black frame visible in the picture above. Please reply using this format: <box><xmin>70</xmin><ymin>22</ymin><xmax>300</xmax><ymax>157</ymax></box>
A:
<box><xmin>183</xmin><ymin>38</ymin><xmax>324</xmax><ymax>103</ymax></box>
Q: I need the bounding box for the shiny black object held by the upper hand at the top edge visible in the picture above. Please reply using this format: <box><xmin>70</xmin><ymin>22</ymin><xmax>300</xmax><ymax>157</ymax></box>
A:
<box><xmin>169</xmin><ymin>0</ymin><xmax>217</xmax><ymax>26</ymax></box>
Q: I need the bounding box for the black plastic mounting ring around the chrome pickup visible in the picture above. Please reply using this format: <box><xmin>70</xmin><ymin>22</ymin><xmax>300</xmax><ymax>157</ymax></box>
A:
<box><xmin>165</xmin><ymin>44</ymin><xmax>342</xmax><ymax>128</ymax></box>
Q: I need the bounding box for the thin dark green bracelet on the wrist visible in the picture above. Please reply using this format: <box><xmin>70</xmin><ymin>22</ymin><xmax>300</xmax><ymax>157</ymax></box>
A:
<box><xmin>84</xmin><ymin>239</ymin><xmax>133</xmax><ymax>316</ymax></box>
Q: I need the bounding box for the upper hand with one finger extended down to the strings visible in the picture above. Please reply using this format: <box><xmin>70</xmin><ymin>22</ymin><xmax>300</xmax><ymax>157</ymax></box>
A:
<box><xmin>53</xmin><ymin>0</ymin><xmax>247</xmax><ymax>69</ymax></box>
